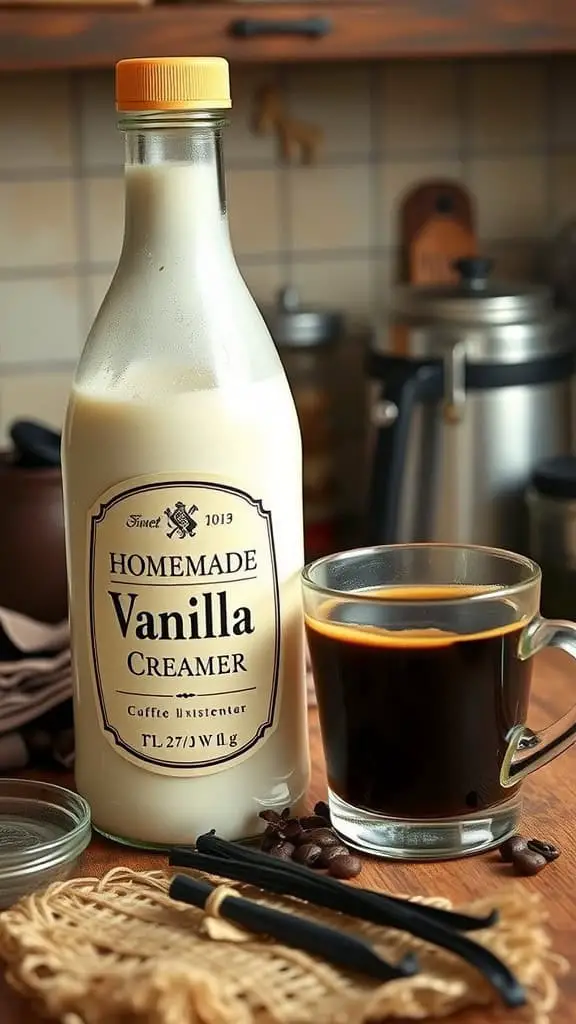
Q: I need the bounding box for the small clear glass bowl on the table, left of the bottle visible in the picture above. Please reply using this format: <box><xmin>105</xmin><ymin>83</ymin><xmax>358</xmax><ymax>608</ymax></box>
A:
<box><xmin>0</xmin><ymin>778</ymin><xmax>91</xmax><ymax>910</ymax></box>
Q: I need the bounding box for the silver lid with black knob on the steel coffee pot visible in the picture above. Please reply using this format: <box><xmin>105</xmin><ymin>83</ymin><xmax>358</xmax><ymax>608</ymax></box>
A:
<box><xmin>394</xmin><ymin>256</ymin><xmax>552</xmax><ymax>327</ymax></box>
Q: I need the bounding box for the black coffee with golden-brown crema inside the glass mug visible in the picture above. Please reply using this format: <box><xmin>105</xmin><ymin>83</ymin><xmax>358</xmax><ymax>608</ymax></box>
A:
<box><xmin>306</xmin><ymin>587</ymin><xmax>531</xmax><ymax>818</ymax></box>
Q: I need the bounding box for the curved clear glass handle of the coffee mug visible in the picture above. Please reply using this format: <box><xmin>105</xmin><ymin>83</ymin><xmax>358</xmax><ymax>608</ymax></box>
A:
<box><xmin>500</xmin><ymin>617</ymin><xmax>576</xmax><ymax>788</ymax></box>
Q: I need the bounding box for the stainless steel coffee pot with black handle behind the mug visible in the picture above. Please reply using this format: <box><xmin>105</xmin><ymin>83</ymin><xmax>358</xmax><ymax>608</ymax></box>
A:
<box><xmin>367</xmin><ymin>257</ymin><xmax>576</xmax><ymax>551</ymax></box>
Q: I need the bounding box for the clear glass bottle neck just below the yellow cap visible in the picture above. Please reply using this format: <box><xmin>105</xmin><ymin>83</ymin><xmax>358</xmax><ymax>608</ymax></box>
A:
<box><xmin>121</xmin><ymin>113</ymin><xmax>231</xmax><ymax>263</ymax></box>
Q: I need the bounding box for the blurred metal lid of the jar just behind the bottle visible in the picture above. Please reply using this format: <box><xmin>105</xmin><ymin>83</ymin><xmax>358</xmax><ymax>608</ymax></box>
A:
<box><xmin>263</xmin><ymin>286</ymin><xmax>343</xmax><ymax>347</ymax></box>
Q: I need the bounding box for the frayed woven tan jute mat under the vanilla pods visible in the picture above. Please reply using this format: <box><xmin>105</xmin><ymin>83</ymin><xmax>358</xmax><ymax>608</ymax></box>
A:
<box><xmin>0</xmin><ymin>867</ymin><xmax>564</xmax><ymax>1024</ymax></box>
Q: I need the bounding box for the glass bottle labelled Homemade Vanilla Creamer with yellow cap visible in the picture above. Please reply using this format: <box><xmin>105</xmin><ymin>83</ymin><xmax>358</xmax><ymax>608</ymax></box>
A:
<box><xmin>64</xmin><ymin>57</ymin><xmax>308</xmax><ymax>846</ymax></box>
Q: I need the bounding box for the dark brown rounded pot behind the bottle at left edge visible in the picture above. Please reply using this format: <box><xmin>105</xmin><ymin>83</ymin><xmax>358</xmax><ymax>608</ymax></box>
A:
<box><xmin>0</xmin><ymin>454</ymin><xmax>68</xmax><ymax>623</ymax></box>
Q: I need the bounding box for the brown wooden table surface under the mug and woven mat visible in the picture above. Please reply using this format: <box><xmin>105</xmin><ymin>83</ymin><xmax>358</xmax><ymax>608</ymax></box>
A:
<box><xmin>0</xmin><ymin>651</ymin><xmax>576</xmax><ymax>1024</ymax></box>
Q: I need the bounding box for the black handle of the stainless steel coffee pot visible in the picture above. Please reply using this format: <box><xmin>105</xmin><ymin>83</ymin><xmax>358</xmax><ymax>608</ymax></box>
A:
<box><xmin>367</xmin><ymin>360</ymin><xmax>443</xmax><ymax>544</ymax></box>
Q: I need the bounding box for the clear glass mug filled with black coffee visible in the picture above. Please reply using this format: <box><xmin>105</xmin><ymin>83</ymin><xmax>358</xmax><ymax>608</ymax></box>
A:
<box><xmin>302</xmin><ymin>544</ymin><xmax>576</xmax><ymax>860</ymax></box>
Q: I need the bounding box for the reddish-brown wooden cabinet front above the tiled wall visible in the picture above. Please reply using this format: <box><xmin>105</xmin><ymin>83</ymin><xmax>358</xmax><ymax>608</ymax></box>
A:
<box><xmin>0</xmin><ymin>0</ymin><xmax>576</xmax><ymax>71</ymax></box>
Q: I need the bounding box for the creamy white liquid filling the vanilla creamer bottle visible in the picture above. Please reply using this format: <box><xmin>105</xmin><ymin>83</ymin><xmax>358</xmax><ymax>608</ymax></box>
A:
<box><xmin>64</xmin><ymin>155</ymin><xmax>310</xmax><ymax>846</ymax></box>
